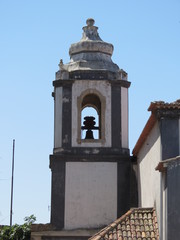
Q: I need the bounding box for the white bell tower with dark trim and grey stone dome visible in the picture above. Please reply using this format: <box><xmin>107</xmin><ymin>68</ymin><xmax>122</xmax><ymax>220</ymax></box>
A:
<box><xmin>50</xmin><ymin>19</ymin><xmax>130</xmax><ymax>230</ymax></box>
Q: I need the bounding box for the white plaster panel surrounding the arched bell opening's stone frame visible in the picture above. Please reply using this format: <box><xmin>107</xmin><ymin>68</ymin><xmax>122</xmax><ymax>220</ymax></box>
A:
<box><xmin>72</xmin><ymin>80</ymin><xmax>111</xmax><ymax>147</ymax></box>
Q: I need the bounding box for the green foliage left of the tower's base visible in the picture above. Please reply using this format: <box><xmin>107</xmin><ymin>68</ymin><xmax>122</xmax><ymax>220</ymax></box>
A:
<box><xmin>0</xmin><ymin>215</ymin><xmax>36</xmax><ymax>240</ymax></box>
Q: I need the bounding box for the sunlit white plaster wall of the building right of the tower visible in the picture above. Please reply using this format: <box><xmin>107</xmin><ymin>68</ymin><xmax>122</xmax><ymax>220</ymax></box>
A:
<box><xmin>138</xmin><ymin>123</ymin><xmax>161</xmax><ymax>223</ymax></box>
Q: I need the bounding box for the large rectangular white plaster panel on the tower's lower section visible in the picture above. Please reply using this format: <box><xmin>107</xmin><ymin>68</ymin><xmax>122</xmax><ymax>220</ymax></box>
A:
<box><xmin>65</xmin><ymin>162</ymin><xmax>117</xmax><ymax>229</ymax></box>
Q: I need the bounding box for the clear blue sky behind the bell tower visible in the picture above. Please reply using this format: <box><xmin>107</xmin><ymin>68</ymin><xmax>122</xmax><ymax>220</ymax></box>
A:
<box><xmin>0</xmin><ymin>0</ymin><xmax>180</xmax><ymax>224</ymax></box>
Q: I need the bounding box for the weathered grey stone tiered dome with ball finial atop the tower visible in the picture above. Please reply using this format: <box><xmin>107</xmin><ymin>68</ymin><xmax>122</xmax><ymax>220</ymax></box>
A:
<box><xmin>56</xmin><ymin>18</ymin><xmax>127</xmax><ymax>80</ymax></box>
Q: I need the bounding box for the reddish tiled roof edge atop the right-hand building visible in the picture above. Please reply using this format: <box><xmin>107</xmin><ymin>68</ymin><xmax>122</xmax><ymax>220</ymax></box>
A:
<box><xmin>148</xmin><ymin>99</ymin><xmax>180</xmax><ymax>111</ymax></box>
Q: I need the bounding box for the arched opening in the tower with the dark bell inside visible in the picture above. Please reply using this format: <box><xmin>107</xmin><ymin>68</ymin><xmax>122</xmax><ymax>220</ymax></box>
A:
<box><xmin>81</xmin><ymin>94</ymin><xmax>101</xmax><ymax>139</ymax></box>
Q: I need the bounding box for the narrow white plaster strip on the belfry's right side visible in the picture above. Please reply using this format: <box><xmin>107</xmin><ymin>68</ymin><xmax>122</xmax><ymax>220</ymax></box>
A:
<box><xmin>121</xmin><ymin>87</ymin><xmax>129</xmax><ymax>148</ymax></box>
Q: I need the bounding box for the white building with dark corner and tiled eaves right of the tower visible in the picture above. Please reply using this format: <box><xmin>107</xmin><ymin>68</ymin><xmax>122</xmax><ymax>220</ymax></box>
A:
<box><xmin>133</xmin><ymin>100</ymin><xmax>180</xmax><ymax>240</ymax></box>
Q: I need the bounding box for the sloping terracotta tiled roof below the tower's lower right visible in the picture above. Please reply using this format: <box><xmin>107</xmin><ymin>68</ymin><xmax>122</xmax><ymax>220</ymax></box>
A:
<box><xmin>89</xmin><ymin>208</ymin><xmax>159</xmax><ymax>240</ymax></box>
